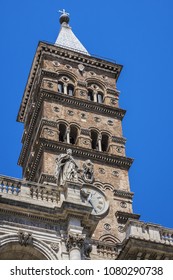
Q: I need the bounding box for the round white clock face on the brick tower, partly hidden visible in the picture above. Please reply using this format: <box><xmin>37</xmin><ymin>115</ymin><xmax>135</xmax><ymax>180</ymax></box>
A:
<box><xmin>81</xmin><ymin>187</ymin><xmax>108</xmax><ymax>215</ymax></box>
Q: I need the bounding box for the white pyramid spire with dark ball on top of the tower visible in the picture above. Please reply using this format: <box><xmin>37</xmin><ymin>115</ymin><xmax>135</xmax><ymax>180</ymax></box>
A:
<box><xmin>55</xmin><ymin>10</ymin><xmax>90</xmax><ymax>55</ymax></box>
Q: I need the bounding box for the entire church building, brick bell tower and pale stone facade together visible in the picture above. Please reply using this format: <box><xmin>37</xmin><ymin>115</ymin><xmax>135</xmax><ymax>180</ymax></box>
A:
<box><xmin>0</xmin><ymin>10</ymin><xmax>173</xmax><ymax>260</ymax></box>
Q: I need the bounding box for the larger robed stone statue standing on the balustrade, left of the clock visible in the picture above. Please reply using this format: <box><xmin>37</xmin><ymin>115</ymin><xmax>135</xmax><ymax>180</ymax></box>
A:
<box><xmin>55</xmin><ymin>149</ymin><xmax>78</xmax><ymax>186</ymax></box>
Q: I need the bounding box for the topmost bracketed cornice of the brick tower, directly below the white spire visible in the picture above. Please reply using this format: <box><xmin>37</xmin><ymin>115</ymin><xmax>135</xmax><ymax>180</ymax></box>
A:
<box><xmin>17</xmin><ymin>42</ymin><xmax>122</xmax><ymax>122</ymax></box>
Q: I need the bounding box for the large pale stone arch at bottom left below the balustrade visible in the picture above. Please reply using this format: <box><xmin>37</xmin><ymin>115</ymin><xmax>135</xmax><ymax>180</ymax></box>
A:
<box><xmin>0</xmin><ymin>234</ymin><xmax>57</xmax><ymax>260</ymax></box>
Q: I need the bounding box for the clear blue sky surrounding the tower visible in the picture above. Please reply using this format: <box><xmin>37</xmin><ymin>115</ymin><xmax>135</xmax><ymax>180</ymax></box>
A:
<box><xmin>0</xmin><ymin>0</ymin><xmax>173</xmax><ymax>228</ymax></box>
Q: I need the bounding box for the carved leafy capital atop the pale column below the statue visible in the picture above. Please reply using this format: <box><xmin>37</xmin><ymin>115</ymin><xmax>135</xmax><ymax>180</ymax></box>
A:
<box><xmin>66</xmin><ymin>233</ymin><xmax>85</xmax><ymax>251</ymax></box>
